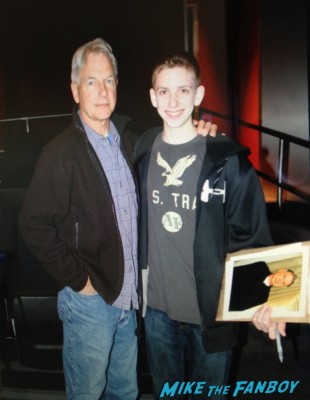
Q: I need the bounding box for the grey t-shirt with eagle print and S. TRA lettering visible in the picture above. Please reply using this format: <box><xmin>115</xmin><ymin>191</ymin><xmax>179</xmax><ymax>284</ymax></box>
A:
<box><xmin>147</xmin><ymin>135</ymin><xmax>206</xmax><ymax>324</ymax></box>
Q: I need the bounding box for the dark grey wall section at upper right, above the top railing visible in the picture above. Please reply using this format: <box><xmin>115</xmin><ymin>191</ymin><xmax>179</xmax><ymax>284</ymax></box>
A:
<box><xmin>261</xmin><ymin>0</ymin><xmax>310</xmax><ymax>139</ymax></box>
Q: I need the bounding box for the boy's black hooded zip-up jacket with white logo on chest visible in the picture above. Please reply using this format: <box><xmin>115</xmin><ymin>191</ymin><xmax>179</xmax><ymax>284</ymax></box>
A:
<box><xmin>136</xmin><ymin>129</ymin><xmax>272</xmax><ymax>352</ymax></box>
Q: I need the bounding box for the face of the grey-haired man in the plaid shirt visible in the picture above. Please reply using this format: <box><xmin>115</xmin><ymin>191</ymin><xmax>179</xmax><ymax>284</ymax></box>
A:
<box><xmin>71</xmin><ymin>53</ymin><xmax>117</xmax><ymax>133</ymax></box>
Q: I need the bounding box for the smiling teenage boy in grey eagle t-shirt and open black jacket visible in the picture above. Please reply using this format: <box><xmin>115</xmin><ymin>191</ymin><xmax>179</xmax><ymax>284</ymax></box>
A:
<box><xmin>137</xmin><ymin>54</ymin><xmax>272</xmax><ymax>399</ymax></box>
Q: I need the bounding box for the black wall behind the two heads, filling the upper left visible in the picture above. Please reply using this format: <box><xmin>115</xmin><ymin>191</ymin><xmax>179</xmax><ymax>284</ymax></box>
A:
<box><xmin>0</xmin><ymin>0</ymin><xmax>184</xmax><ymax>134</ymax></box>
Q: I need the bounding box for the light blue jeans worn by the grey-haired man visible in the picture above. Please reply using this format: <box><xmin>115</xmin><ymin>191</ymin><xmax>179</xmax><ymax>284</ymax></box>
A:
<box><xmin>58</xmin><ymin>287</ymin><xmax>138</xmax><ymax>400</ymax></box>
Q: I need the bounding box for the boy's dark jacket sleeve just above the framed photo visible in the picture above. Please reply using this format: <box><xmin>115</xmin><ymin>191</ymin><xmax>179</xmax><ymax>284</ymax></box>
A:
<box><xmin>225</xmin><ymin>155</ymin><xmax>272</xmax><ymax>252</ymax></box>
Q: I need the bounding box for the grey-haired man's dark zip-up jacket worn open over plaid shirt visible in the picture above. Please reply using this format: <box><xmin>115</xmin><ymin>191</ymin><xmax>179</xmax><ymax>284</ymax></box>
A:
<box><xmin>19</xmin><ymin>109</ymin><xmax>137</xmax><ymax>304</ymax></box>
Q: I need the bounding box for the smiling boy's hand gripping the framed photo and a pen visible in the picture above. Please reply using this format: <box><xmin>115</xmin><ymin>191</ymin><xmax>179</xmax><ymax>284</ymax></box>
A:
<box><xmin>252</xmin><ymin>305</ymin><xmax>286</xmax><ymax>340</ymax></box>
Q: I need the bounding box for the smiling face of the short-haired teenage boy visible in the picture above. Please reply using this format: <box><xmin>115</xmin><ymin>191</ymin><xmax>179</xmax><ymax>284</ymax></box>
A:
<box><xmin>150</xmin><ymin>67</ymin><xmax>204</xmax><ymax>128</ymax></box>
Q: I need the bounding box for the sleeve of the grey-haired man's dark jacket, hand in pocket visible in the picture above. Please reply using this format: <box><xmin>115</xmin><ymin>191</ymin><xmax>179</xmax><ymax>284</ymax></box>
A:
<box><xmin>19</xmin><ymin>149</ymin><xmax>89</xmax><ymax>291</ymax></box>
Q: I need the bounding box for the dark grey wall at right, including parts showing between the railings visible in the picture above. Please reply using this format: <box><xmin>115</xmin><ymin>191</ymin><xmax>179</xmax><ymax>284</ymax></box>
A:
<box><xmin>261</xmin><ymin>0</ymin><xmax>310</xmax><ymax>200</ymax></box>
